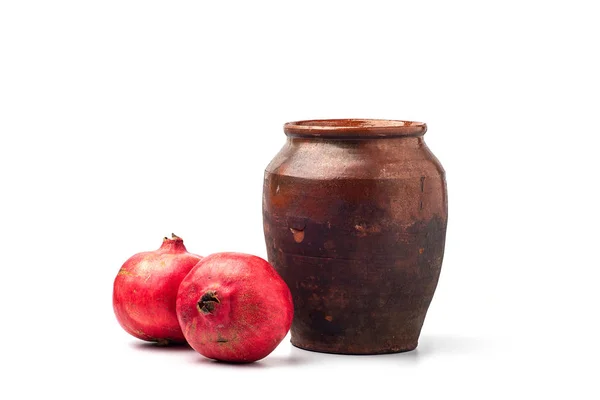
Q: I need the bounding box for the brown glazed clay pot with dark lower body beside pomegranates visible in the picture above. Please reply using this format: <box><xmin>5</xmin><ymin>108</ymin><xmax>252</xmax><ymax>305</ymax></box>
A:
<box><xmin>263</xmin><ymin>119</ymin><xmax>448</xmax><ymax>354</ymax></box>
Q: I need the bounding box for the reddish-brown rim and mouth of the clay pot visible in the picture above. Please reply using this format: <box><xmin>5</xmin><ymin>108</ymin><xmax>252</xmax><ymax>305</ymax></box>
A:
<box><xmin>283</xmin><ymin>119</ymin><xmax>427</xmax><ymax>139</ymax></box>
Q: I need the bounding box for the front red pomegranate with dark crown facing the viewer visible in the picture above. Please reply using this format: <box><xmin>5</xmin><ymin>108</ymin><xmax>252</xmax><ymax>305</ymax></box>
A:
<box><xmin>177</xmin><ymin>253</ymin><xmax>294</xmax><ymax>363</ymax></box>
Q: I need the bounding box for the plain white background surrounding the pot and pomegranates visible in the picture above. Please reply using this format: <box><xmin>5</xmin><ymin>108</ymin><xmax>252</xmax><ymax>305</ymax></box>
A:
<box><xmin>0</xmin><ymin>0</ymin><xmax>600</xmax><ymax>400</ymax></box>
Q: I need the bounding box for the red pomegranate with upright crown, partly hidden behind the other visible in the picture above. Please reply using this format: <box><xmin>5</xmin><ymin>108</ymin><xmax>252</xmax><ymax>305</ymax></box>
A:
<box><xmin>113</xmin><ymin>235</ymin><xmax>202</xmax><ymax>345</ymax></box>
